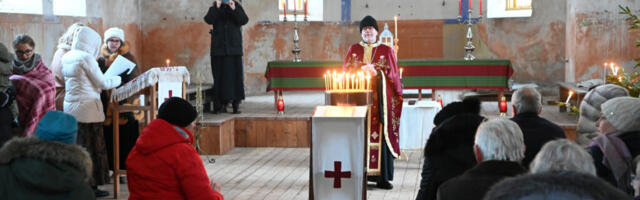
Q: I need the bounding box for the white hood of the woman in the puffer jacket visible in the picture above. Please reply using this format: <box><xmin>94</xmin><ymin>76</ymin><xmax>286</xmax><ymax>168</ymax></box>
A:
<box><xmin>71</xmin><ymin>26</ymin><xmax>102</xmax><ymax>58</ymax></box>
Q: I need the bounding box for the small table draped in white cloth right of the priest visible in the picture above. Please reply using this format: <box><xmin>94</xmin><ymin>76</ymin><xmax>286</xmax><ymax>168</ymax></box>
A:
<box><xmin>400</xmin><ymin>100</ymin><xmax>441</xmax><ymax>150</ymax></box>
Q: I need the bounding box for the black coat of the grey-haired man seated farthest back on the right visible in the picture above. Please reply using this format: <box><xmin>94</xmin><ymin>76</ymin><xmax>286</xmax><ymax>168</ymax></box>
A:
<box><xmin>511</xmin><ymin>113</ymin><xmax>566</xmax><ymax>168</ymax></box>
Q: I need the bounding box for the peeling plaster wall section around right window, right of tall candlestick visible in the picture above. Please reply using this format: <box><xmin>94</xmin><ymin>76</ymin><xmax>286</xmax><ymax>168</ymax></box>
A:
<box><xmin>477</xmin><ymin>0</ymin><xmax>566</xmax><ymax>93</ymax></box>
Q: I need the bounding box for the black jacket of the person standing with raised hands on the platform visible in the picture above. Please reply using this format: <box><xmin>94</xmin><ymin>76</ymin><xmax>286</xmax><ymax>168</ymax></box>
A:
<box><xmin>204</xmin><ymin>1</ymin><xmax>249</xmax><ymax>56</ymax></box>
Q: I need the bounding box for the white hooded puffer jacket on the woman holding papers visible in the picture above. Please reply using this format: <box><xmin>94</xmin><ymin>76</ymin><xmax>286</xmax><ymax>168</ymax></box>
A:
<box><xmin>62</xmin><ymin>27</ymin><xmax>121</xmax><ymax>123</ymax></box>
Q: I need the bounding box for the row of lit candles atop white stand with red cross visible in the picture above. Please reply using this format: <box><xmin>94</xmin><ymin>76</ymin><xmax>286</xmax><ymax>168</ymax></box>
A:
<box><xmin>324</xmin><ymin>70</ymin><xmax>371</xmax><ymax>92</ymax></box>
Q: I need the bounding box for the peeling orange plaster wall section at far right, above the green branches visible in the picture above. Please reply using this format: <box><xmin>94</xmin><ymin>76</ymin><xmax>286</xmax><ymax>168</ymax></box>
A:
<box><xmin>566</xmin><ymin>0</ymin><xmax>640</xmax><ymax>81</ymax></box>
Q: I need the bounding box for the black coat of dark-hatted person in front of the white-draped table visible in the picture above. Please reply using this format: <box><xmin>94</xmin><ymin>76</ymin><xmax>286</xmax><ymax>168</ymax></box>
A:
<box><xmin>416</xmin><ymin>114</ymin><xmax>485</xmax><ymax>200</ymax></box>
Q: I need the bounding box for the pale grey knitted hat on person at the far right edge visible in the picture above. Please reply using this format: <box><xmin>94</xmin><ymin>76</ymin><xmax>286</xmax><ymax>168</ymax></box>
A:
<box><xmin>602</xmin><ymin>97</ymin><xmax>640</xmax><ymax>132</ymax></box>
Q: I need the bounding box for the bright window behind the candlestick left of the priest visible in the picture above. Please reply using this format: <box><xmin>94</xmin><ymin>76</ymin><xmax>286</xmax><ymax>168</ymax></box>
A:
<box><xmin>278</xmin><ymin>0</ymin><xmax>324</xmax><ymax>21</ymax></box>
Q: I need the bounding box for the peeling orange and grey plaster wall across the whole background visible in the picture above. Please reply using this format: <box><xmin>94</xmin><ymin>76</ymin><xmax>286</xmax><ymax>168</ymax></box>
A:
<box><xmin>7</xmin><ymin>0</ymin><xmax>640</xmax><ymax>95</ymax></box>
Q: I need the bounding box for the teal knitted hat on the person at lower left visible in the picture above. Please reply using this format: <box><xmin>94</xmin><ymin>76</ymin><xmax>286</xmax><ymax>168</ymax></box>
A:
<box><xmin>34</xmin><ymin>110</ymin><xmax>78</xmax><ymax>144</ymax></box>
